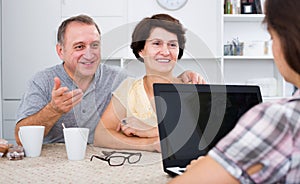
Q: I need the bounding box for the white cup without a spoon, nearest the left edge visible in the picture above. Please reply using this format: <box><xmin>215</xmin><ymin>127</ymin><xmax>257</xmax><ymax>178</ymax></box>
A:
<box><xmin>18</xmin><ymin>126</ymin><xmax>45</xmax><ymax>157</ymax></box>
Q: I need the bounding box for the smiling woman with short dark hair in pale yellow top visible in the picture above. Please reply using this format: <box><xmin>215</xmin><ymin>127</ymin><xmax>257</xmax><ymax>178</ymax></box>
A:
<box><xmin>94</xmin><ymin>14</ymin><xmax>191</xmax><ymax>151</ymax></box>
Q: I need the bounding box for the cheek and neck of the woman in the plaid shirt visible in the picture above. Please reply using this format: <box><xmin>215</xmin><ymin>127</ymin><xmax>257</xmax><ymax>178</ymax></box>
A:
<box><xmin>269</xmin><ymin>28</ymin><xmax>299</xmax><ymax>86</ymax></box>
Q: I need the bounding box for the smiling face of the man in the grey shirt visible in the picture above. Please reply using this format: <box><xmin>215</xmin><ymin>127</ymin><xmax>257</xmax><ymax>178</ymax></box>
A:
<box><xmin>57</xmin><ymin>22</ymin><xmax>101</xmax><ymax>80</ymax></box>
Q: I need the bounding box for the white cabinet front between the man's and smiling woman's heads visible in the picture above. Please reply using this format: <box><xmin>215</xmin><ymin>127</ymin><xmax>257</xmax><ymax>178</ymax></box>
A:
<box><xmin>61</xmin><ymin>0</ymin><xmax>129</xmax><ymax>58</ymax></box>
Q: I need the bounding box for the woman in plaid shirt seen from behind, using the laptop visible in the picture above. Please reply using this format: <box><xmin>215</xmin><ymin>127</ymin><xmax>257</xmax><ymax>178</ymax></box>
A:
<box><xmin>171</xmin><ymin>0</ymin><xmax>300</xmax><ymax>184</ymax></box>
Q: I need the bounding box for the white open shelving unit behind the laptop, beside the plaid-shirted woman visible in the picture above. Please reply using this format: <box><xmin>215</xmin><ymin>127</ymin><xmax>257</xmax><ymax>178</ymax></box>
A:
<box><xmin>222</xmin><ymin>9</ymin><xmax>292</xmax><ymax>100</ymax></box>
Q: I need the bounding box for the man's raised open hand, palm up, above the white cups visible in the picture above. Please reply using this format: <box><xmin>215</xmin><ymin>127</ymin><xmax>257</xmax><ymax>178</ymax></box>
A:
<box><xmin>50</xmin><ymin>77</ymin><xmax>83</xmax><ymax>114</ymax></box>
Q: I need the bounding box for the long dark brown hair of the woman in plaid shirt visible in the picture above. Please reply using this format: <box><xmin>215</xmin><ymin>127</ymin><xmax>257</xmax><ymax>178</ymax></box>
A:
<box><xmin>263</xmin><ymin>0</ymin><xmax>300</xmax><ymax>74</ymax></box>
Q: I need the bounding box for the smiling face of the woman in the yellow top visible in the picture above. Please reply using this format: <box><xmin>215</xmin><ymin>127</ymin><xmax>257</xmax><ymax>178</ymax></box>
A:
<box><xmin>139</xmin><ymin>27</ymin><xmax>179</xmax><ymax>75</ymax></box>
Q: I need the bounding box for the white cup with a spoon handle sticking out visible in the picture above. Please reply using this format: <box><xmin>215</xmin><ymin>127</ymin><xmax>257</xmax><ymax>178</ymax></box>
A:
<box><xmin>63</xmin><ymin>128</ymin><xmax>89</xmax><ymax>160</ymax></box>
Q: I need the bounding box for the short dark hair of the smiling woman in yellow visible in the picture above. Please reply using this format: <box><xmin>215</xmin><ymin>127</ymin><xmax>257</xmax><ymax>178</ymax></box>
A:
<box><xmin>130</xmin><ymin>14</ymin><xmax>186</xmax><ymax>62</ymax></box>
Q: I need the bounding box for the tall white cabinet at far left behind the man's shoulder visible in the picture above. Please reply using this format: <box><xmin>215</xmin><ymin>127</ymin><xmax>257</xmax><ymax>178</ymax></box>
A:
<box><xmin>0</xmin><ymin>0</ymin><xmax>61</xmax><ymax>143</ymax></box>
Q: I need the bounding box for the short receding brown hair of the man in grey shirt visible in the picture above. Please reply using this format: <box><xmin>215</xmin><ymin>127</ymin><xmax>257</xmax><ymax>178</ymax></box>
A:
<box><xmin>57</xmin><ymin>15</ymin><xmax>101</xmax><ymax>45</ymax></box>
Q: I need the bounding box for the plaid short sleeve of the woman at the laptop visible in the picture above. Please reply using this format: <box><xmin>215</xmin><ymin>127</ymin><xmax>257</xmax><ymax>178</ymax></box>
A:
<box><xmin>209</xmin><ymin>104</ymin><xmax>293</xmax><ymax>183</ymax></box>
